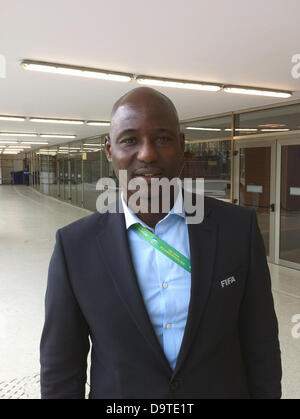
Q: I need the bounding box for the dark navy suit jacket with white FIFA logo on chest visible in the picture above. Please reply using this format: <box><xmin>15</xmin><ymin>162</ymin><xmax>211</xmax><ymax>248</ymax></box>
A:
<box><xmin>40</xmin><ymin>198</ymin><xmax>281</xmax><ymax>399</ymax></box>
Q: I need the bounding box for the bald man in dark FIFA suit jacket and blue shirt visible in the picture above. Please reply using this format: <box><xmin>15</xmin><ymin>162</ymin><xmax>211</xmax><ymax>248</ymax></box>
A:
<box><xmin>41</xmin><ymin>88</ymin><xmax>281</xmax><ymax>399</ymax></box>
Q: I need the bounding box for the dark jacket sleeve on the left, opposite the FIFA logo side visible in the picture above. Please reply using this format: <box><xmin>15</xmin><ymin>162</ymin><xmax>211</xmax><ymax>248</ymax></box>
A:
<box><xmin>40</xmin><ymin>231</ymin><xmax>89</xmax><ymax>399</ymax></box>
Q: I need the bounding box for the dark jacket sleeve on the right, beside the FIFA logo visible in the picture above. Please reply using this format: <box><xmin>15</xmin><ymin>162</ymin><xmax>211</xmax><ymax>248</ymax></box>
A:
<box><xmin>239</xmin><ymin>211</ymin><xmax>282</xmax><ymax>399</ymax></box>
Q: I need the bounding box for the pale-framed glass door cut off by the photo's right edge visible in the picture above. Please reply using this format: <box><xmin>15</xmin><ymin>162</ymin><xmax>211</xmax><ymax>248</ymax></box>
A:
<box><xmin>276</xmin><ymin>139</ymin><xmax>300</xmax><ymax>269</ymax></box>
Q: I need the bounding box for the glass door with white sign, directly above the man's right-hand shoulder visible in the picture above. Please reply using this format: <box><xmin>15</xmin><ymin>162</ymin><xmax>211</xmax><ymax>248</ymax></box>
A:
<box><xmin>234</xmin><ymin>141</ymin><xmax>276</xmax><ymax>262</ymax></box>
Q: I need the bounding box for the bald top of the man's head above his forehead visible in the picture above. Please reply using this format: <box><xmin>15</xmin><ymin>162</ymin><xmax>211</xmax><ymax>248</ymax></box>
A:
<box><xmin>110</xmin><ymin>87</ymin><xmax>179</xmax><ymax>128</ymax></box>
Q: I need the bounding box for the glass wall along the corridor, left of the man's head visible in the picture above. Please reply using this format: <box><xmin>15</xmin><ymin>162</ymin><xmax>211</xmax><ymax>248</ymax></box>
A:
<box><xmin>26</xmin><ymin>137</ymin><xmax>114</xmax><ymax>211</ymax></box>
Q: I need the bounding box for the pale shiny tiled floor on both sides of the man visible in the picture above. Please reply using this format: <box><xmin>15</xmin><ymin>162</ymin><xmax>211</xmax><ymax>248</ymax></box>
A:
<box><xmin>0</xmin><ymin>186</ymin><xmax>300</xmax><ymax>399</ymax></box>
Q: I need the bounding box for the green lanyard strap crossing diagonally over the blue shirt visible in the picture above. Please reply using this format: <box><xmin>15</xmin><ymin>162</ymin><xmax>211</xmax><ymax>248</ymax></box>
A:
<box><xmin>131</xmin><ymin>223</ymin><xmax>191</xmax><ymax>272</ymax></box>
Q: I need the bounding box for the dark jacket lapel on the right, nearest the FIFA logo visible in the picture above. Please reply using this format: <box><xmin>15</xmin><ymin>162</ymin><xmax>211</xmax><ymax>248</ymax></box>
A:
<box><xmin>173</xmin><ymin>202</ymin><xmax>217</xmax><ymax>376</ymax></box>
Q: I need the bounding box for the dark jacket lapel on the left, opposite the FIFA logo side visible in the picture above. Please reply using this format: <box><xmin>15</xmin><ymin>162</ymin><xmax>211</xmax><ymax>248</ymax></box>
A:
<box><xmin>97</xmin><ymin>213</ymin><xmax>172</xmax><ymax>375</ymax></box>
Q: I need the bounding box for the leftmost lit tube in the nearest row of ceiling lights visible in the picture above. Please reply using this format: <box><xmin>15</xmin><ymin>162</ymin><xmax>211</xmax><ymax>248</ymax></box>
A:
<box><xmin>21</xmin><ymin>60</ymin><xmax>133</xmax><ymax>82</ymax></box>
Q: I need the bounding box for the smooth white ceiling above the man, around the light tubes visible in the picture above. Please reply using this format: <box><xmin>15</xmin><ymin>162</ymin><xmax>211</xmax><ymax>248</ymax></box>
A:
<box><xmin>0</xmin><ymin>0</ymin><xmax>300</xmax><ymax>149</ymax></box>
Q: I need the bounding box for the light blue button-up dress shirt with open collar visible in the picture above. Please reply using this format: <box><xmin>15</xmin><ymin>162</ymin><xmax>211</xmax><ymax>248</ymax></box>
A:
<box><xmin>121</xmin><ymin>191</ymin><xmax>191</xmax><ymax>369</ymax></box>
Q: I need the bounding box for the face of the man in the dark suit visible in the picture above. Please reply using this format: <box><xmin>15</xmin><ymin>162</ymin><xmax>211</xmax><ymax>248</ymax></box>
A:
<box><xmin>105</xmin><ymin>100</ymin><xmax>184</xmax><ymax>200</ymax></box>
